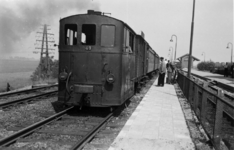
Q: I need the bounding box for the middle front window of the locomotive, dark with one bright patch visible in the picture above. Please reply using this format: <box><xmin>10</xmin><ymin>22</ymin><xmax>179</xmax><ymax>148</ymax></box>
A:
<box><xmin>81</xmin><ymin>24</ymin><xmax>96</xmax><ymax>45</ymax></box>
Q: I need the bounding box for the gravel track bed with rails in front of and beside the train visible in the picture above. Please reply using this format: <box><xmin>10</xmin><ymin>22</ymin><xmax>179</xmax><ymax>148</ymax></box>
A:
<box><xmin>0</xmin><ymin>75</ymin><xmax>157</xmax><ymax>150</ymax></box>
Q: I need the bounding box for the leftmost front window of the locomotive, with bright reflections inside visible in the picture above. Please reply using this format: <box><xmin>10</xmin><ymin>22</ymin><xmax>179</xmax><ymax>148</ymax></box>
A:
<box><xmin>65</xmin><ymin>24</ymin><xmax>77</xmax><ymax>45</ymax></box>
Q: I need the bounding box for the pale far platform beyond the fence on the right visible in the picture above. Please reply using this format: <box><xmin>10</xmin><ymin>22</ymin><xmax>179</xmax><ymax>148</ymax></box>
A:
<box><xmin>183</xmin><ymin>68</ymin><xmax>234</xmax><ymax>87</ymax></box>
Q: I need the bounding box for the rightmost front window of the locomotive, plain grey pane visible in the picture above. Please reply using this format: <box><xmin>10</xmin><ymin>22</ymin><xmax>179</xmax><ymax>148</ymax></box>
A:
<box><xmin>101</xmin><ymin>25</ymin><xmax>115</xmax><ymax>47</ymax></box>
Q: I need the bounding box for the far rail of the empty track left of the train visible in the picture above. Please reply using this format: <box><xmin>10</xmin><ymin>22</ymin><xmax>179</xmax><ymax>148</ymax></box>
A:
<box><xmin>0</xmin><ymin>84</ymin><xmax>58</xmax><ymax>98</ymax></box>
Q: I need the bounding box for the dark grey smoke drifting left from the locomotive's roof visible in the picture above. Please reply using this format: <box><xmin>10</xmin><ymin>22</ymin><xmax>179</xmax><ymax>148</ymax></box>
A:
<box><xmin>0</xmin><ymin>0</ymin><xmax>99</xmax><ymax>55</ymax></box>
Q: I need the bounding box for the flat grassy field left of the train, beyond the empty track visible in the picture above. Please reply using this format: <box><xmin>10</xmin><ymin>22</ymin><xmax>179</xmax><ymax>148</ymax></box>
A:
<box><xmin>0</xmin><ymin>59</ymin><xmax>57</xmax><ymax>92</ymax></box>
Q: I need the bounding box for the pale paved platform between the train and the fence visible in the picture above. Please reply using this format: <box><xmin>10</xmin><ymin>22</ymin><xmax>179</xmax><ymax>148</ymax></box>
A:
<box><xmin>109</xmin><ymin>80</ymin><xmax>195</xmax><ymax>150</ymax></box>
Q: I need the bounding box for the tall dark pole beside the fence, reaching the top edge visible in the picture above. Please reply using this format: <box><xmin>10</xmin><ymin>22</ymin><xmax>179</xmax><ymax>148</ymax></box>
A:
<box><xmin>187</xmin><ymin>0</ymin><xmax>195</xmax><ymax>78</ymax></box>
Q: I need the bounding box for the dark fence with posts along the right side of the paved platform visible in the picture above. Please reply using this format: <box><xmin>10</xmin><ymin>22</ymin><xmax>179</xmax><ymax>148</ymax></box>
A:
<box><xmin>177</xmin><ymin>72</ymin><xmax>234</xmax><ymax>150</ymax></box>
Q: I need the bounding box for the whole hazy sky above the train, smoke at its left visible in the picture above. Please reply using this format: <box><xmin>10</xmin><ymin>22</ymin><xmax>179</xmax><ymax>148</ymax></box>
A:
<box><xmin>0</xmin><ymin>0</ymin><xmax>234</xmax><ymax>62</ymax></box>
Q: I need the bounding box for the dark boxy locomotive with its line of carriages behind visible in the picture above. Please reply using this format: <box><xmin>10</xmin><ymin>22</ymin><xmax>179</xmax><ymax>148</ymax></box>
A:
<box><xmin>58</xmin><ymin>10</ymin><xmax>159</xmax><ymax>107</ymax></box>
